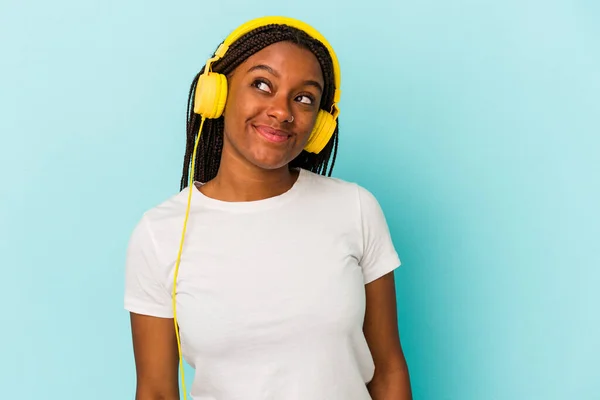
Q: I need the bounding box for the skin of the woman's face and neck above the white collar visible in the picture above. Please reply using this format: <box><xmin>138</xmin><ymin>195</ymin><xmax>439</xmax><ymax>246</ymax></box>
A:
<box><xmin>200</xmin><ymin>42</ymin><xmax>324</xmax><ymax>201</ymax></box>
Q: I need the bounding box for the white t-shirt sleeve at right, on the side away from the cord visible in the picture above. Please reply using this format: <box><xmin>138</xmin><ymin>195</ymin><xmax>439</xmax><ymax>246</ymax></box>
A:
<box><xmin>358</xmin><ymin>186</ymin><xmax>401</xmax><ymax>284</ymax></box>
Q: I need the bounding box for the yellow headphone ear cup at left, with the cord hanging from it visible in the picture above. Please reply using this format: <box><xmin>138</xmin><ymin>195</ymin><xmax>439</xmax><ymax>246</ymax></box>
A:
<box><xmin>194</xmin><ymin>72</ymin><xmax>227</xmax><ymax>119</ymax></box>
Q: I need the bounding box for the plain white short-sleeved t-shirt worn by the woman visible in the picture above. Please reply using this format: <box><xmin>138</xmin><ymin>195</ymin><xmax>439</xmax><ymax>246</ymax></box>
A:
<box><xmin>125</xmin><ymin>170</ymin><xmax>400</xmax><ymax>400</ymax></box>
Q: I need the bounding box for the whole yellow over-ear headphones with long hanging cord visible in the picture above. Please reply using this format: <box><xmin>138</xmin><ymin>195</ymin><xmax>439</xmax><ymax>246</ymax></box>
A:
<box><xmin>172</xmin><ymin>16</ymin><xmax>341</xmax><ymax>399</ymax></box>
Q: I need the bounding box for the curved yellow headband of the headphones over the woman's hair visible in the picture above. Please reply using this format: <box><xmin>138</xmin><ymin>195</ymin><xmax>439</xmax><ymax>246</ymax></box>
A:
<box><xmin>205</xmin><ymin>16</ymin><xmax>342</xmax><ymax>118</ymax></box>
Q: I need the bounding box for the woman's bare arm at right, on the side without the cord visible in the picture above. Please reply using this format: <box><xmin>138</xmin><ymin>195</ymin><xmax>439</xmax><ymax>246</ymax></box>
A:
<box><xmin>364</xmin><ymin>272</ymin><xmax>412</xmax><ymax>400</ymax></box>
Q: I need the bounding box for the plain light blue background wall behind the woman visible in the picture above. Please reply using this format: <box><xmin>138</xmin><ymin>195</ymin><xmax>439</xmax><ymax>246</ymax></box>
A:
<box><xmin>0</xmin><ymin>0</ymin><xmax>600</xmax><ymax>400</ymax></box>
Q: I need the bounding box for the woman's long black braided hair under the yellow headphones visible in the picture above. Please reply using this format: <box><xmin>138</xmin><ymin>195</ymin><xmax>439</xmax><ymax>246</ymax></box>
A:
<box><xmin>181</xmin><ymin>25</ymin><xmax>339</xmax><ymax>189</ymax></box>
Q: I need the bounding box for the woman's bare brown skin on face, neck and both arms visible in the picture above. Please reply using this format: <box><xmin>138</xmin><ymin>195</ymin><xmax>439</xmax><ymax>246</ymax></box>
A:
<box><xmin>131</xmin><ymin>42</ymin><xmax>412</xmax><ymax>400</ymax></box>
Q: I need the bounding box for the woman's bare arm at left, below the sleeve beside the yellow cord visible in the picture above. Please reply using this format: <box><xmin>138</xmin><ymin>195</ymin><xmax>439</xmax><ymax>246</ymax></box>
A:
<box><xmin>130</xmin><ymin>313</ymin><xmax>179</xmax><ymax>400</ymax></box>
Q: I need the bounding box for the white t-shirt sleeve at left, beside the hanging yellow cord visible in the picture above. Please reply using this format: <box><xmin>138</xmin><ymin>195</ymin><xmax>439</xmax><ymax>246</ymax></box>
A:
<box><xmin>124</xmin><ymin>217</ymin><xmax>173</xmax><ymax>318</ymax></box>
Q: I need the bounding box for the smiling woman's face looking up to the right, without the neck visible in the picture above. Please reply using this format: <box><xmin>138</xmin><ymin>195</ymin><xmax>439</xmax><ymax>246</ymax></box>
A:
<box><xmin>223</xmin><ymin>42</ymin><xmax>324</xmax><ymax>169</ymax></box>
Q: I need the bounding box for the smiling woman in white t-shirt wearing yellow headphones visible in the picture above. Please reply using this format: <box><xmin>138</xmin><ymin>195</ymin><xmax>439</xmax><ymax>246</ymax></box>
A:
<box><xmin>125</xmin><ymin>17</ymin><xmax>411</xmax><ymax>400</ymax></box>
